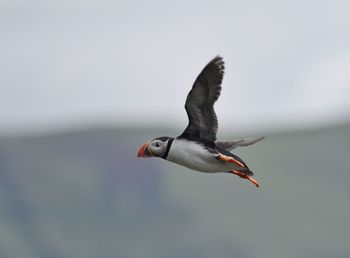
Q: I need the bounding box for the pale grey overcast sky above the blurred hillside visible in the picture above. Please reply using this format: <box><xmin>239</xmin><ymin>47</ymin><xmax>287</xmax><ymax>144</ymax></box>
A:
<box><xmin>0</xmin><ymin>0</ymin><xmax>350</xmax><ymax>135</ymax></box>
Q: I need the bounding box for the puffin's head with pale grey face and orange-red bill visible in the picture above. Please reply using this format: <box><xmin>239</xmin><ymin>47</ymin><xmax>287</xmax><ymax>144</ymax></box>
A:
<box><xmin>137</xmin><ymin>136</ymin><xmax>171</xmax><ymax>158</ymax></box>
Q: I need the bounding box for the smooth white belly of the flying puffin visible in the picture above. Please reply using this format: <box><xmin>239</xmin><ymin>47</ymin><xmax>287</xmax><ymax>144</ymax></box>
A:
<box><xmin>167</xmin><ymin>139</ymin><xmax>238</xmax><ymax>173</ymax></box>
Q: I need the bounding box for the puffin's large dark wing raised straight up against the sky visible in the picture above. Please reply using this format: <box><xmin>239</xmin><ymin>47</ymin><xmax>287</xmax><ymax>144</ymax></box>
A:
<box><xmin>179</xmin><ymin>56</ymin><xmax>225</xmax><ymax>146</ymax></box>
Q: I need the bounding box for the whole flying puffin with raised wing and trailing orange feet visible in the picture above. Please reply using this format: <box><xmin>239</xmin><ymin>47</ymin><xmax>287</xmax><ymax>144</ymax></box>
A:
<box><xmin>137</xmin><ymin>56</ymin><xmax>264</xmax><ymax>187</ymax></box>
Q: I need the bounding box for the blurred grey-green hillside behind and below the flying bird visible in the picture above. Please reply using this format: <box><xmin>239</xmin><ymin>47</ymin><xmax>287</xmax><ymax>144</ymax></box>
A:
<box><xmin>0</xmin><ymin>125</ymin><xmax>350</xmax><ymax>258</ymax></box>
